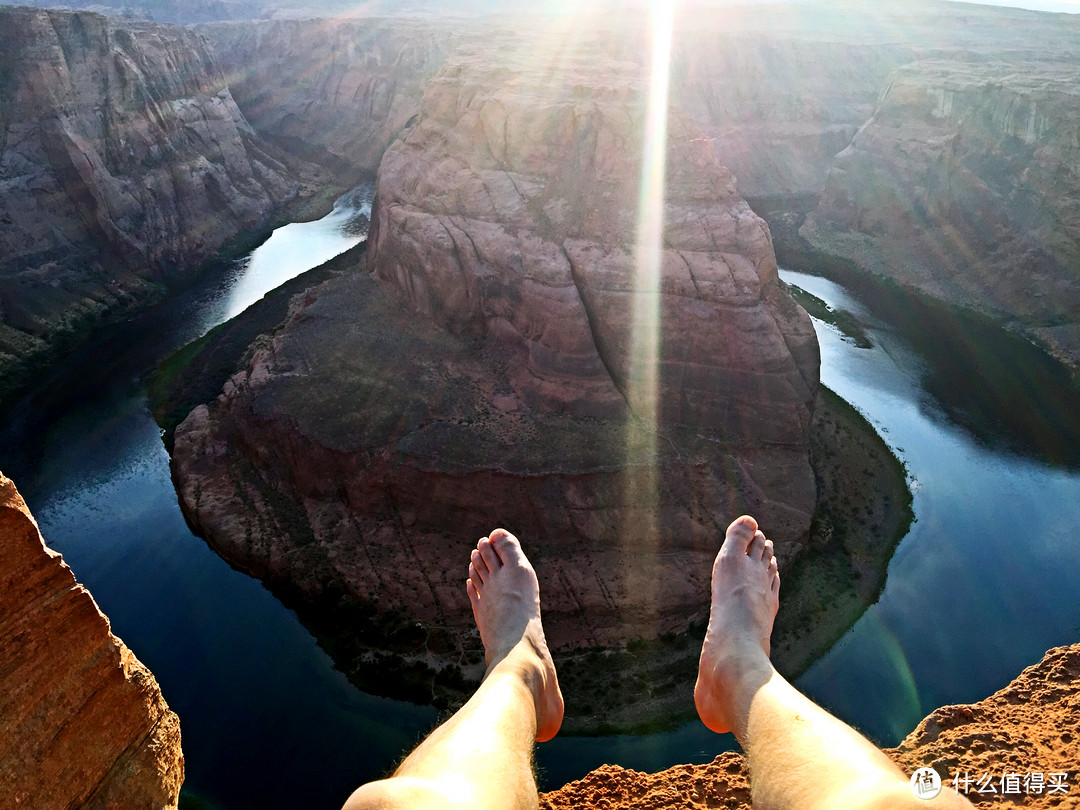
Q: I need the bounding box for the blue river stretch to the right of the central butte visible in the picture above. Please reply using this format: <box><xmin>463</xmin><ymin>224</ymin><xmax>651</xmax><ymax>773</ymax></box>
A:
<box><xmin>783</xmin><ymin>272</ymin><xmax>1080</xmax><ymax>744</ymax></box>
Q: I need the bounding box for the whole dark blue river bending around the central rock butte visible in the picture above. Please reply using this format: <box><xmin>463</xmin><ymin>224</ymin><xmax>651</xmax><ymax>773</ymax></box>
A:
<box><xmin>0</xmin><ymin>188</ymin><xmax>1080</xmax><ymax>810</ymax></box>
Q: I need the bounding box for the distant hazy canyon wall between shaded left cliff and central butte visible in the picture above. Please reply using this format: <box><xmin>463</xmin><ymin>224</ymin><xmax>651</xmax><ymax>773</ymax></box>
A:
<box><xmin>200</xmin><ymin>18</ymin><xmax>462</xmax><ymax>174</ymax></box>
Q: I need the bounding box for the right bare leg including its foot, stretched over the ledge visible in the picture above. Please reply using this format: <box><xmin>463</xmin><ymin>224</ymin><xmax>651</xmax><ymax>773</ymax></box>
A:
<box><xmin>693</xmin><ymin>515</ymin><xmax>971</xmax><ymax>810</ymax></box>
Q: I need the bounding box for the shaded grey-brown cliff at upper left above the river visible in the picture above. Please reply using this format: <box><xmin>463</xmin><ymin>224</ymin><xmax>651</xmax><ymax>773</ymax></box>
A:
<box><xmin>0</xmin><ymin>8</ymin><xmax>295</xmax><ymax>406</ymax></box>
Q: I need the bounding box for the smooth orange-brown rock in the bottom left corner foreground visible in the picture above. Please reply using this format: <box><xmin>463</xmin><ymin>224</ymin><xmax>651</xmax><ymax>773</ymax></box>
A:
<box><xmin>0</xmin><ymin>474</ymin><xmax>184</xmax><ymax>810</ymax></box>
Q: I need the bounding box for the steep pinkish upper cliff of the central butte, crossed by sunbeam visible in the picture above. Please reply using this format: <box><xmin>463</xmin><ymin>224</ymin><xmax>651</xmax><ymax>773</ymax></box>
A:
<box><xmin>370</xmin><ymin>41</ymin><xmax>818</xmax><ymax>445</ymax></box>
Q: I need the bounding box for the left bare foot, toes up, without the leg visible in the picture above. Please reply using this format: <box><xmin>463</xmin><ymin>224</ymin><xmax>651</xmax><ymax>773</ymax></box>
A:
<box><xmin>465</xmin><ymin>529</ymin><xmax>563</xmax><ymax>742</ymax></box>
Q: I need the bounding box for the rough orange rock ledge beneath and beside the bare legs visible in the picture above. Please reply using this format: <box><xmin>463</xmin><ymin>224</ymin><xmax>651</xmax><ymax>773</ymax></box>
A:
<box><xmin>540</xmin><ymin>645</ymin><xmax>1080</xmax><ymax>810</ymax></box>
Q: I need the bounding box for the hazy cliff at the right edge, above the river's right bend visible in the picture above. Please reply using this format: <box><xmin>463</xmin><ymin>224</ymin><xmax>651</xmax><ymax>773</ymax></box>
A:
<box><xmin>801</xmin><ymin>60</ymin><xmax>1080</xmax><ymax>366</ymax></box>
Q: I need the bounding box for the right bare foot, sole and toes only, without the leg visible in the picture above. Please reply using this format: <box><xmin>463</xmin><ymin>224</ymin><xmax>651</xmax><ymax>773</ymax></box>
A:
<box><xmin>693</xmin><ymin>515</ymin><xmax>780</xmax><ymax>733</ymax></box>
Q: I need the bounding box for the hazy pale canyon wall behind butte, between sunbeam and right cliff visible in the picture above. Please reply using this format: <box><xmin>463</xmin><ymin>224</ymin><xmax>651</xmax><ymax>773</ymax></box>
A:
<box><xmin>672</xmin><ymin>34</ymin><xmax>915</xmax><ymax>201</ymax></box>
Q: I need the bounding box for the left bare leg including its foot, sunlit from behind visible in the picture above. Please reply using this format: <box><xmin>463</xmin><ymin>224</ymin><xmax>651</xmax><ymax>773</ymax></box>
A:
<box><xmin>345</xmin><ymin>529</ymin><xmax>563</xmax><ymax>810</ymax></box>
